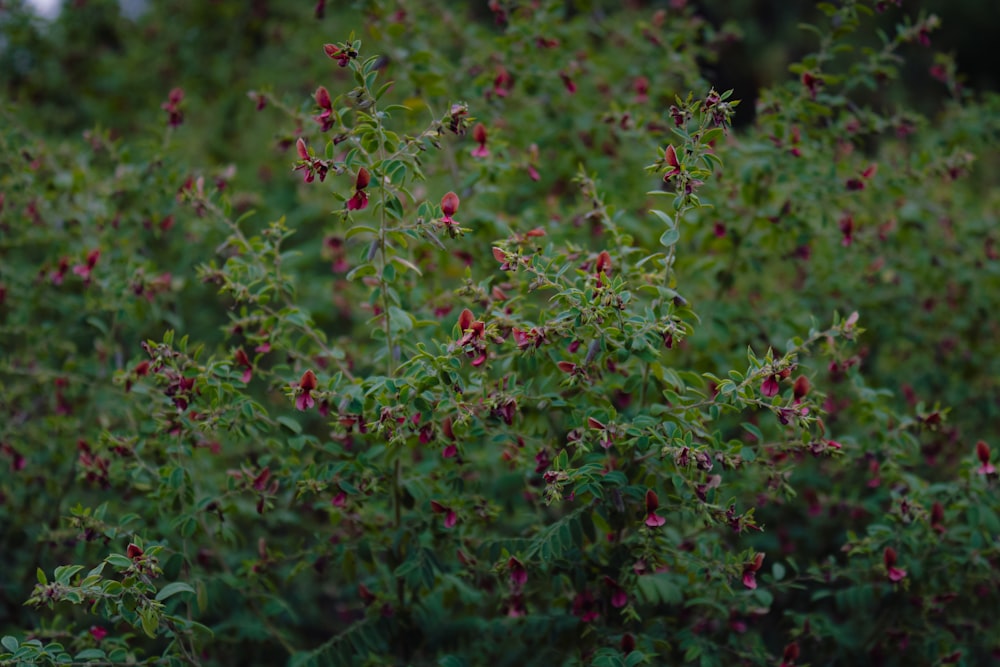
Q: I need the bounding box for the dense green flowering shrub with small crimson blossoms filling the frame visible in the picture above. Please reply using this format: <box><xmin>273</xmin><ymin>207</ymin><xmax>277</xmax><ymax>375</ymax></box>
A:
<box><xmin>0</xmin><ymin>1</ymin><xmax>1000</xmax><ymax>665</ymax></box>
